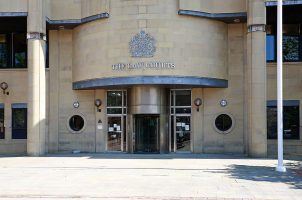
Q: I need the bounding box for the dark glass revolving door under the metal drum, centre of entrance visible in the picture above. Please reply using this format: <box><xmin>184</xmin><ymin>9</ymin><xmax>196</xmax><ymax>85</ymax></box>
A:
<box><xmin>135</xmin><ymin>115</ymin><xmax>159</xmax><ymax>153</ymax></box>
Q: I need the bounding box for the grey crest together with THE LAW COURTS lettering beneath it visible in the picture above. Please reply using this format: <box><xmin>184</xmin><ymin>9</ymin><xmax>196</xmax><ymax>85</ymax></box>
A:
<box><xmin>112</xmin><ymin>31</ymin><xmax>175</xmax><ymax>71</ymax></box>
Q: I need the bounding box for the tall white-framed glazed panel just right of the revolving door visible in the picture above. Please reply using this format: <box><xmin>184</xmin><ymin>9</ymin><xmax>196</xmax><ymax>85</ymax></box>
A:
<box><xmin>170</xmin><ymin>90</ymin><xmax>191</xmax><ymax>152</ymax></box>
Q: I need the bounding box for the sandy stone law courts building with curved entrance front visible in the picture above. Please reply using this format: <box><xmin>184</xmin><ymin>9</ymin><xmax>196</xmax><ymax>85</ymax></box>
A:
<box><xmin>0</xmin><ymin>0</ymin><xmax>302</xmax><ymax>157</ymax></box>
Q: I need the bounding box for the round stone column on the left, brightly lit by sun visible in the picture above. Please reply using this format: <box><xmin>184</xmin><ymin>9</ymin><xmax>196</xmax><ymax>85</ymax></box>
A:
<box><xmin>27</xmin><ymin>0</ymin><xmax>46</xmax><ymax>156</ymax></box>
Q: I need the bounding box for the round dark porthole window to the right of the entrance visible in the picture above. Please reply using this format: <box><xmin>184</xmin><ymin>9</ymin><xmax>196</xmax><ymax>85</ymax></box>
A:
<box><xmin>214</xmin><ymin>114</ymin><xmax>234</xmax><ymax>134</ymax></box>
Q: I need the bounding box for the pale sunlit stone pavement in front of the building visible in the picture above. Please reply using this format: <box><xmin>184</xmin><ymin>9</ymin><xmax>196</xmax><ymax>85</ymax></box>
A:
<box><xmin>0</xmin><ymin>154</ymin><xmax>302</xmax><ymax>200</ymax></box>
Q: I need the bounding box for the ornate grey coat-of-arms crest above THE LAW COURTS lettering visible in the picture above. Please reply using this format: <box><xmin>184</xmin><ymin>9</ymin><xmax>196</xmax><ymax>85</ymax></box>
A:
<box><xmin>129</xmin><ymin>31</ymin><xmax>156</xmax><ymax>58</ymax></box>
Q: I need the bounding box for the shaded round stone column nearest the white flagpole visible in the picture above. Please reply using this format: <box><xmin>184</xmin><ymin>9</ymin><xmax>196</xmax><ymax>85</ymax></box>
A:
<box><xmin>245</xmin><ymin>0</ymin><xmax>267</xmax><ymax>157</ymax></box>
